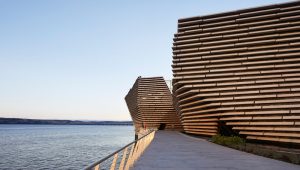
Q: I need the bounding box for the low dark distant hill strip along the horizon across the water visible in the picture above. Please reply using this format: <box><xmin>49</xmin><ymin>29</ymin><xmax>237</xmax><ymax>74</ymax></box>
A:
<box><xmin>0</xmin><ymin>117</ymin><xmax>133</xmax><ymax>125</ymax></box>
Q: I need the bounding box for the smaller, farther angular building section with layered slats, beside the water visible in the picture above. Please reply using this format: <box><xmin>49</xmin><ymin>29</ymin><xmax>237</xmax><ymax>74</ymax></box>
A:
<box><xmin>125</xmin><ymin>77</ymin><xmax>182</xmax><ymax>132</ymax></box>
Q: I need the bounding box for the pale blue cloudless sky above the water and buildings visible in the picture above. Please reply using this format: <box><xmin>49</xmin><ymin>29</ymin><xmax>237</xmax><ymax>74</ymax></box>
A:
<box><xmin>0</xmin><ymin>0</ymin><xmax>287</xmax><ymax>120</ymax></box>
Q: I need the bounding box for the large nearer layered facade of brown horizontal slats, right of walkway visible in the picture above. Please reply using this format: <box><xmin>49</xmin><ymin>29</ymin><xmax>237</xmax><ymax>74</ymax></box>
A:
<box><xmin>172</xmin><ymin>1</ymin><xmax>300</xmax><ymax>143</ymax></box>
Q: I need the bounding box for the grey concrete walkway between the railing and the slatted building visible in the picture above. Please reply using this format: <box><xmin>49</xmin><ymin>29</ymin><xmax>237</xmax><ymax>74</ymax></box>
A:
<box><xmin>133</xmin><ymin>131</ymin><xmax>300</xmax><ymax>170</ymax></box>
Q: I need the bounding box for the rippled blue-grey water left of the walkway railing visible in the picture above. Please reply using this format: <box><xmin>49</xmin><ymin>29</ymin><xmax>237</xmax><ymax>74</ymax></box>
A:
<box><xmin>0</xmin><ymin>125</ymin><xmax>134</xmax><ymax>170</ymax></box>
